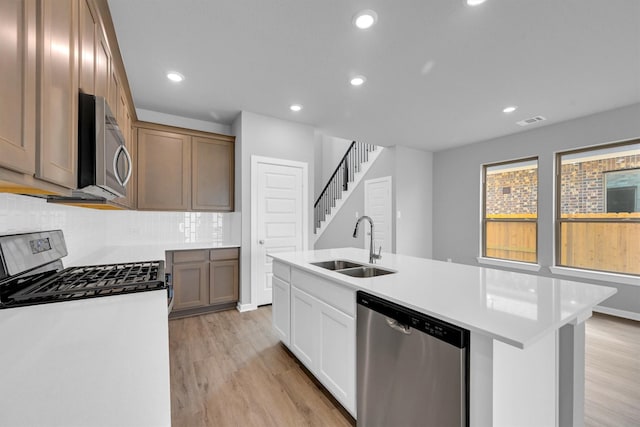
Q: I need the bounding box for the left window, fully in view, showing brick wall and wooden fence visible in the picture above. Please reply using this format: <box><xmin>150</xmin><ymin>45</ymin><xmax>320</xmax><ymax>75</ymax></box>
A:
<box><xmin>482</xmin><ymin>158</ymin><xmax>538</xmax><ymax>263</ymax></box>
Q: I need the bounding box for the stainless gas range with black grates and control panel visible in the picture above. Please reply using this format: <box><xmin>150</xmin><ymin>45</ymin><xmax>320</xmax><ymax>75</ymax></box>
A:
<box><xmin>0</xmin><ymin>230</ymin><xmax>172</xmax><ymax>309</ymax></box>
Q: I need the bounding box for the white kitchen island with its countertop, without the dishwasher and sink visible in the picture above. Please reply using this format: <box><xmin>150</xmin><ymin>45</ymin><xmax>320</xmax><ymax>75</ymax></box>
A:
<box><xmin>270</xmin><ymin>248</ymin><xmax>616</xmax><ymax>427</ymax></box>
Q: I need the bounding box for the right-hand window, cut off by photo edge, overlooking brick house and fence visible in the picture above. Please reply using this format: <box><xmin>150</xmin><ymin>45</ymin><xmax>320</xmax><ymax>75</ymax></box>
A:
<box><xmin>556</xmin><ymin>140</ymin><xmax>640</xmax><ymax>275</ymax></box>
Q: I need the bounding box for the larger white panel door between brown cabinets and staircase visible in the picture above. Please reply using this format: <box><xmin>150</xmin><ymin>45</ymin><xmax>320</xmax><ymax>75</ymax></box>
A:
<box><xmin>252</xmin><ymin>162</ymin><xmax>306</xmax><ymax>305</ymax></box>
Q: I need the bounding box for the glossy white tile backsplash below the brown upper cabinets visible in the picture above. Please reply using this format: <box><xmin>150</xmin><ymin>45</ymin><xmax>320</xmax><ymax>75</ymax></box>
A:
<box><xmin>0</xmin><ymin>193</ymin><xmax>242</xmax><ymax>264</ymax></box>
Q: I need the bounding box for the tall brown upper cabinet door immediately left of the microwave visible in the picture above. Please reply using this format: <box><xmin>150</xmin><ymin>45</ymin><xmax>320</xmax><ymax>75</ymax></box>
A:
<box><xmin>36</xmin><ymin>0</ymin><xmax>78</xmax><ymax>188</ymax></box>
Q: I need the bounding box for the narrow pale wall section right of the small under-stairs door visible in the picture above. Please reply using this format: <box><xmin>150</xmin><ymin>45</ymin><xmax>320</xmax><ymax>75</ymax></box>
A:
<box><xmin>394</xmin><ymin>146</ymin><xmax>433</xmax><ymax>258</ymax></box>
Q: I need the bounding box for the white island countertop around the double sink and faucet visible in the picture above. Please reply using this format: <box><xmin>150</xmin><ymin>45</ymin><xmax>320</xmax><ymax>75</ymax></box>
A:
<box><xmin>270</xmin><ymin>248</ymin><xmax>616</xmax><ymax>348</ymax></box>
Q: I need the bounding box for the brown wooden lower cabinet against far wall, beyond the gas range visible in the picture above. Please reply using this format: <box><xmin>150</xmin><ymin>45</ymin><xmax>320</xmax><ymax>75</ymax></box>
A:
<box><xmin>166</xmin><ymin>248</ymin><xmax>239</xmax><ymax>318</ymax></box>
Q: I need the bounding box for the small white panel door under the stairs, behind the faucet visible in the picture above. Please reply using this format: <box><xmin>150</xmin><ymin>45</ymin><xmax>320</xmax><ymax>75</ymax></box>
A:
<box><xmin>362</xmin><ymin>176</ymin><xmax>393</xmax><ymax>252</ymax></box>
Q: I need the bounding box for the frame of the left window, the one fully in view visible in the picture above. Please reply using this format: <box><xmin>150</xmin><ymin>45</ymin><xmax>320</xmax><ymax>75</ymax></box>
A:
<box><xmin>478</xmin><ymin>156</ymin><xmax>540</xmax><ymax>264</ymax></box>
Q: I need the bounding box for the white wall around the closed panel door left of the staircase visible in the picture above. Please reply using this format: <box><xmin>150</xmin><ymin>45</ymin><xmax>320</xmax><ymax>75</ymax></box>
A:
<box><xmin>232</xmin><ymin>111</ymin><xmax>315</xmax><ymax>305</ymax></box>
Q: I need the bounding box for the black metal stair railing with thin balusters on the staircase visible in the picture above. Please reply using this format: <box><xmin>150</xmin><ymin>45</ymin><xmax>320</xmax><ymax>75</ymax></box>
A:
<box><xmin>313</xmin><ymin>141</ymin><xmax>376</xmax><ymax>233</ymax></box>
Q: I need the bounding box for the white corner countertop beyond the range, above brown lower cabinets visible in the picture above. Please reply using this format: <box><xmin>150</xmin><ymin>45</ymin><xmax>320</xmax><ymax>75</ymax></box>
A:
<box><xmin>62</xmin><ymin>241</ymin><xmax>240</xmax><ymax>267</ymax></box>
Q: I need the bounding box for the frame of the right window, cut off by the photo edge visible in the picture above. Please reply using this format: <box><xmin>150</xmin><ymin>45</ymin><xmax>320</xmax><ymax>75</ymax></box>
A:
<box><xmin>550</xmin><ymin>138</ymin><xmax>640</xmax><ymax>278</ymax></box>
